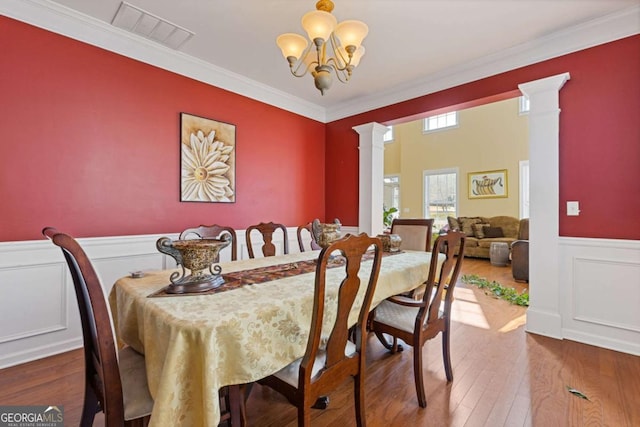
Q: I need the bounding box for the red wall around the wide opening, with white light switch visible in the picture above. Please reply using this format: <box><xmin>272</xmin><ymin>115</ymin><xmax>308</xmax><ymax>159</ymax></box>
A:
<box><xmin>326</xmin><ymin>35</ymin><xmax>640</xmax><ymax>240</ymax></box>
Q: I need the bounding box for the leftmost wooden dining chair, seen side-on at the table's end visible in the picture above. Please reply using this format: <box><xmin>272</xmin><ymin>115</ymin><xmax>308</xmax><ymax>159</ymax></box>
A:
<box><xmin>42</xmin><ymin>227</ymin><xmax>153</xmax><ymax>427</ymax></box>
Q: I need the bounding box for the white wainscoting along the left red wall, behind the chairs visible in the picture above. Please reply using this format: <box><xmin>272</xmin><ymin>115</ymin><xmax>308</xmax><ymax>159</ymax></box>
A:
<box><xmin>0</xmin><ymin>227</ymin><xmax>357</xmax><ymax>369</ymax></box>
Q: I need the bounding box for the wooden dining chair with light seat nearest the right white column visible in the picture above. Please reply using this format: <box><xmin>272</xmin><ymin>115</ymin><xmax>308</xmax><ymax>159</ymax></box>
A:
<box><xmin>369</xmin><ymin>232</ymin><xmax>466</xmax><ymax>408</ymax></box>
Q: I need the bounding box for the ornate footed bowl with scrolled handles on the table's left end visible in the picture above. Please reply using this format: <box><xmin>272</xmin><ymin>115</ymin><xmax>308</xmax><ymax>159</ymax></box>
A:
<box><xmin>156</xmin><ymin>235</ymin><xmax>231</xmax><ymax>293</ymax></box>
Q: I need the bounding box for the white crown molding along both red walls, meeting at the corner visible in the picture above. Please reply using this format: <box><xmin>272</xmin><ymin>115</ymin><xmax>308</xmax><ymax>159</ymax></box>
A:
<box><xmin>0</xmin><ymin>0</ymin><xmax>640</xmax><ymax>123</ymax></box>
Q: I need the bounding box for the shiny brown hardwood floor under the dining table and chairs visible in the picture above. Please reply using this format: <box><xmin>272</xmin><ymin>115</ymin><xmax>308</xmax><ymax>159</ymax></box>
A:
<box><xmin>0</xmin><ymin>259</ymin><xmax>640</xmax><ymax>427</ymax></box>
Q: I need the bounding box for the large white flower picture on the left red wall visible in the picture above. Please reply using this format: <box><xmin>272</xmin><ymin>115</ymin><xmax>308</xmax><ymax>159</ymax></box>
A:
<box><xmin>180</xmin><ymin>113</ymin><xmax>236</xmax><ymax>203</ymax></box>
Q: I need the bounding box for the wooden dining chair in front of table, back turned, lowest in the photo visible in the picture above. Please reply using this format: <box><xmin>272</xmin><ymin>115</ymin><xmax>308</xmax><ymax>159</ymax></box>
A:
<box><xmin>259</xmin><ymin>233</ymin><xmax>382</xmax><ymax>426</ymax></box>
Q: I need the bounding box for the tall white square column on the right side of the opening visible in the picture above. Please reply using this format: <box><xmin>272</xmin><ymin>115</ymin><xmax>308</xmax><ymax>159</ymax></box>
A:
<box><xmin>518</xmin><ymin>73</ymin><xmax>570</xmax><ymax>338</ymax></box>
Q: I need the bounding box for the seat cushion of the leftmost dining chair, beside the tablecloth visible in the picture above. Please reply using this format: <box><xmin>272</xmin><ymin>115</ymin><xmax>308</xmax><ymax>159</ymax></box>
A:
<box><xmin>118</xmin><ymin>347</ymin><xmax>153</xmax><ymax>421</ymax></box>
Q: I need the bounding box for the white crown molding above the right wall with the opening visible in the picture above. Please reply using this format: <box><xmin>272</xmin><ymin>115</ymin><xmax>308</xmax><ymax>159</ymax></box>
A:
<box><xmin>327</xmin><ymin>5</ymin><xmax>640</xmax><ymax>122</ymax></box>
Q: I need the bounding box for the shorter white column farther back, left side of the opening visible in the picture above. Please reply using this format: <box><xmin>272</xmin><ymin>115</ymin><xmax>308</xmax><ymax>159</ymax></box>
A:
<box><xmin>353</xmin><ymin>123</ymin><xmax>387</xmax><ymax>236</ymax></box>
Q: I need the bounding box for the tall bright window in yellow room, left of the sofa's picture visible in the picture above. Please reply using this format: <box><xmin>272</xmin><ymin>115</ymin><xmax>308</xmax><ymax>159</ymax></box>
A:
<box><xmin>423</xmin><ymin>168</ymin><xmax>458</xmax><ymax>230</ymax></box>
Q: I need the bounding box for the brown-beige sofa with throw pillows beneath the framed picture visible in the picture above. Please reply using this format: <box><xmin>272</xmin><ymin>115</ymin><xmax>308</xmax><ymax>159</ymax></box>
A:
<box><xmin>447</xmin><ymin>216</ymin><xmax>523</xmax><ymax>258</ymax></box>
